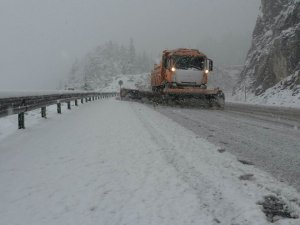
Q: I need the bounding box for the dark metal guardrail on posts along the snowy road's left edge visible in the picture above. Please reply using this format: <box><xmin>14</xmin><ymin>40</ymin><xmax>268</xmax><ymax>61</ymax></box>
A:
<box><xmin>0</xmin><ymin>92</ymin><xmax>117</xmax><ymax>129</ymax></box>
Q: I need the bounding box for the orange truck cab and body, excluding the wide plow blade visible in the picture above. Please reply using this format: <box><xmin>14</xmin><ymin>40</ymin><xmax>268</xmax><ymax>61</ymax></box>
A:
<box><xmin>151</xmin><ymin>48</ymin><xmax>219</xmax><ymax>94</ymax></box>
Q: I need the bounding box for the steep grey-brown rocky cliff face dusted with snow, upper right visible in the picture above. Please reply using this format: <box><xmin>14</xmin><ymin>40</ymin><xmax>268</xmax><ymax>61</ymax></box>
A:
<box><xmin>234</xmin><ymin>0</ymin><xmax>300</xmax><ymax>96</ymax></box>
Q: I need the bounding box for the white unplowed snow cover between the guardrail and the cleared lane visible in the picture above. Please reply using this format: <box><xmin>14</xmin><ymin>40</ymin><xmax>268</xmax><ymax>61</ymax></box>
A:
<box><xmin>0</xmin><ymin>99</ymin><xmax>300</xmax><ymax>225</ymax></box>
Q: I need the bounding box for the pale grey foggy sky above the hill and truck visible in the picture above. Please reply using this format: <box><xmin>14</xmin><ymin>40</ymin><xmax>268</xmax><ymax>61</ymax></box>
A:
<box><xmin>0</xmin><ymin>0</ymin><xmax>260</xmax><ymax>90</ymax></box>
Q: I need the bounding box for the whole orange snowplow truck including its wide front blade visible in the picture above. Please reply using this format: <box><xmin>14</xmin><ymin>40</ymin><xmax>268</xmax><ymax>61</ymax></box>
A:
<box><xmin>120</xmin><ymin>48</ymin><xmax>225</xmax><ymax>108</ymax></box>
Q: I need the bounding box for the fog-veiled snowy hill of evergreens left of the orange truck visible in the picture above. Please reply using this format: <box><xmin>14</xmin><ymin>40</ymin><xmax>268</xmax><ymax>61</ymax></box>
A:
<box><xmin>67</xmin><ymin>39</ymin><xmax>154</xmax><ymax>90</ymax></box>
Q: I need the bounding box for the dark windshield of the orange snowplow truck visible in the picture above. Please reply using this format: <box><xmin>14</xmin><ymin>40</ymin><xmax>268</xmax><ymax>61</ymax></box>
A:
<box><xmin>173</xmin><ymin>56</ymin><xmax>204</xmax><ymax>70</ymax></box>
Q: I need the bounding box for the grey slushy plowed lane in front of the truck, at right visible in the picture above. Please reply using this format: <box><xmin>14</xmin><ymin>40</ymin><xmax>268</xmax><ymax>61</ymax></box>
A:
<box><xmin>157</xmin><ymin>104</ymin><xmax>300</xmax><ymax>191</ymax></box>
